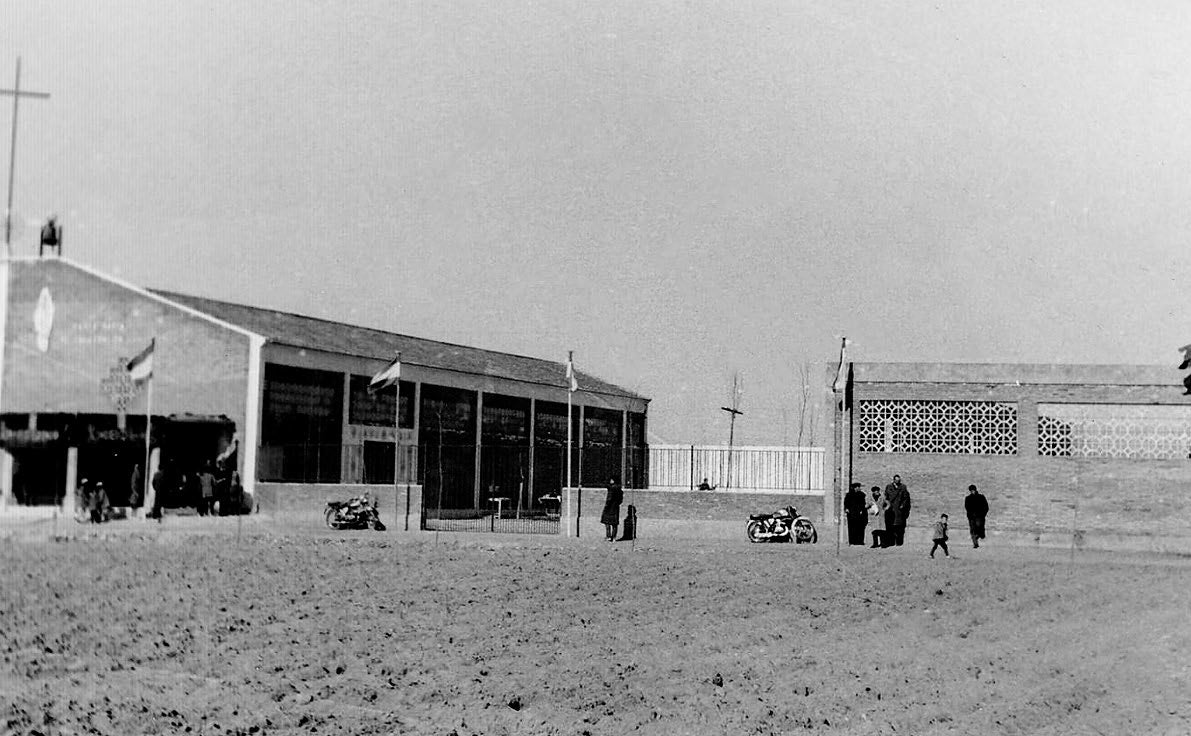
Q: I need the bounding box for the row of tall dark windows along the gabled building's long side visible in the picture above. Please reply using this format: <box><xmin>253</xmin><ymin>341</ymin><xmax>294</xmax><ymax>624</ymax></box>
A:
<box><xmin>260</xmin><ymin>363</ymin><xmax>647</xmax><ymax>497</ymax></box>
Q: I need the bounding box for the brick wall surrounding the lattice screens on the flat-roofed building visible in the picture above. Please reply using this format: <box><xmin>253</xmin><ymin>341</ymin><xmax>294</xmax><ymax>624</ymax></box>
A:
<box><xmin>853</xmin><ymin>366</ymin><xmax>1191</xmax><ymax>545</ymax></box>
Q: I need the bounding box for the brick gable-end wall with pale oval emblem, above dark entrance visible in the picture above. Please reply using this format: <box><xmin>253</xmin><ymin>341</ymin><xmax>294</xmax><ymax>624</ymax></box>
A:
<box><xmin>4</xmin><ymin>260</ymin><xmax>249</xmax><ymax>432</ymax></box>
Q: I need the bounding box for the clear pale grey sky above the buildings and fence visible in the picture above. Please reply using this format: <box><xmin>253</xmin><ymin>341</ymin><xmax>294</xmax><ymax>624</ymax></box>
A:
<box><xmin>0</xmin><ymin>0</ymin><xmax>1191</xmax><ymax>445</ymax></box>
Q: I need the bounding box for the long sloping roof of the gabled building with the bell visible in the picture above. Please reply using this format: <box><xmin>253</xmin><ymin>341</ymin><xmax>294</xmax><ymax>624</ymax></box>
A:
<box><xmin>149</xmin><ymin>289</ymin><xmax>648</xmax><ymax>400</ymax></box>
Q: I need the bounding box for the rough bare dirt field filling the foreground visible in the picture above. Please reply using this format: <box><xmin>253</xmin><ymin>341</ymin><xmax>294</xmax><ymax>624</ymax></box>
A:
<box><xmin>0</xmin><ymin>519</ymin><xmax>1191</xmax><ymax>736</ymax></box>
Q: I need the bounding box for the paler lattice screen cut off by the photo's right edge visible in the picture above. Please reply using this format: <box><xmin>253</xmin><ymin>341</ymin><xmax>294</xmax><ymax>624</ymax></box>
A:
<box><xmin>1039</xmin><ymin>404</ymin><xmax>1191</xmax><ymax>460</ymax></box>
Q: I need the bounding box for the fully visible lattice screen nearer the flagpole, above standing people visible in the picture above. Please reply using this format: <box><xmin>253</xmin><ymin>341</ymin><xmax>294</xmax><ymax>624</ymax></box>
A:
<box><xmin>856</xmin><ymin>400</ymin><xmax>1017</xmax><ymax>455</ymax></box>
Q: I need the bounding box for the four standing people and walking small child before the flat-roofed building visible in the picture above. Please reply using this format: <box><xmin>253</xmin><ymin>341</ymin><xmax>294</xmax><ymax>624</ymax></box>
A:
<box><xmin>843</xmin><ymin>475</ymin><xmax>989</xmax><ymax>557</ymax></box>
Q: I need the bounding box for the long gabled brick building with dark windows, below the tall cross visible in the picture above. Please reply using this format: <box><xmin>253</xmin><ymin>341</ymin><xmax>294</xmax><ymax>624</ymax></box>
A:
<box><xmin>0</xmin><ymin>257</ymin><xmax>649</xmax><ymax>509</ymax></box>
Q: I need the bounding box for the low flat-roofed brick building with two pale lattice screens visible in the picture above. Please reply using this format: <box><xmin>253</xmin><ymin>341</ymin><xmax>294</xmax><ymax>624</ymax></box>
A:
<box><xmin>833</xmin><ymin>363</ymin><xmax>1191</xmax><ymax>539</ymax></box>
